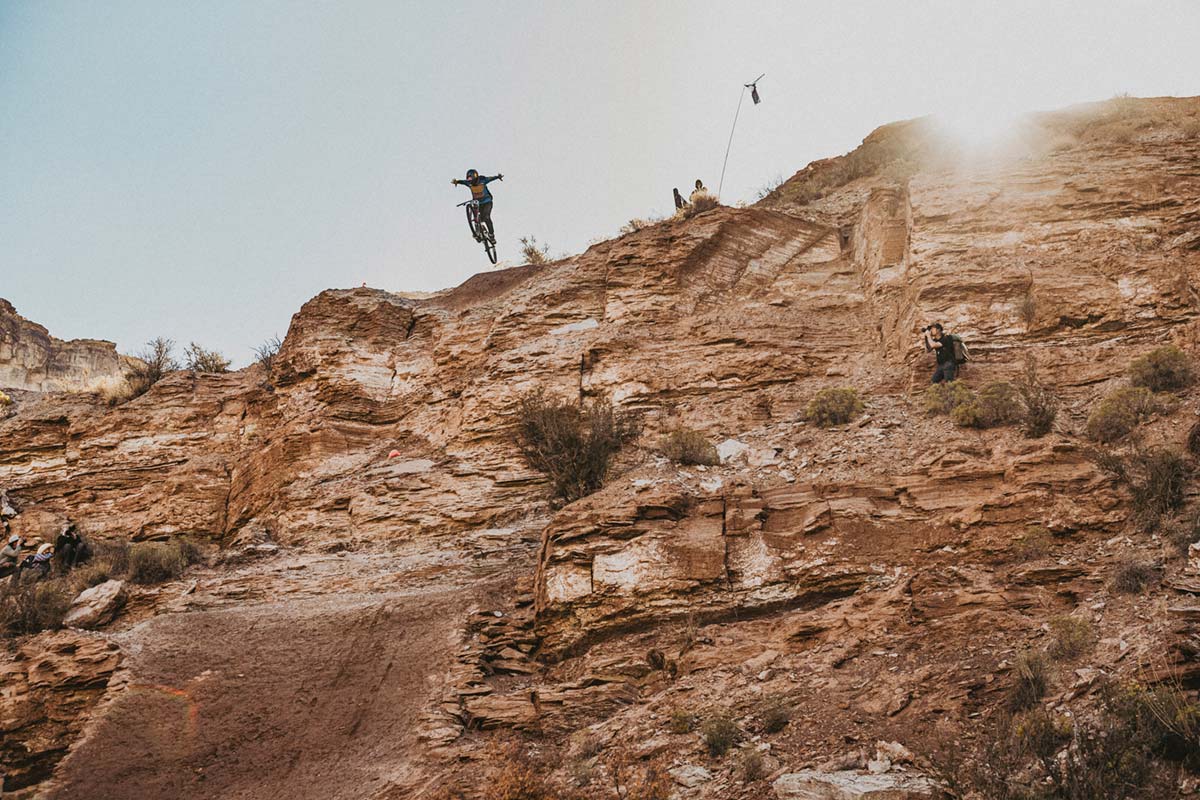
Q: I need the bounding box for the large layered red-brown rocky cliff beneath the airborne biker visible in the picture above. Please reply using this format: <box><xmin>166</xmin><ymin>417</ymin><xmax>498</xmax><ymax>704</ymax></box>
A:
<box><xmin>0</xmin><ymin>100</ymin><xmax>1200</xmax><ymax>798</ymax></box>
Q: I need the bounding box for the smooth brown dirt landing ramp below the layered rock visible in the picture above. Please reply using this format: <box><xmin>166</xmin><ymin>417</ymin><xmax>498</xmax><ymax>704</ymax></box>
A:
<box><xmin>41</xmin><ymin>542</ymin><xmax>530</xmax><ymax>800</ymax></box>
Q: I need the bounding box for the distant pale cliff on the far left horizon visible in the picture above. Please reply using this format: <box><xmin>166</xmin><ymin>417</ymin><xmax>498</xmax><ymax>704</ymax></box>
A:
<box><xmin>0</xmin><ymin>297</ymin><xmax>126</xmax><ymax>392</ymax></box>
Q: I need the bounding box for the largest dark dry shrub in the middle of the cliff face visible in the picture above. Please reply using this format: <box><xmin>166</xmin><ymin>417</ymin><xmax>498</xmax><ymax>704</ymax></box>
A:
<box><xmin>515</xmin><ymin>391</ymin><xmax>640</xmax><ymax>501</ymax></box>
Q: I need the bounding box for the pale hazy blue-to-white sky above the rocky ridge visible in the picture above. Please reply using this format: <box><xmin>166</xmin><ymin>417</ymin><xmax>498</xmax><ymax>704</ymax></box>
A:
<box><xmin>0</xmin><ymin>0</ymin><xmax>1200</xmax><ymax>365</ymax></box>
